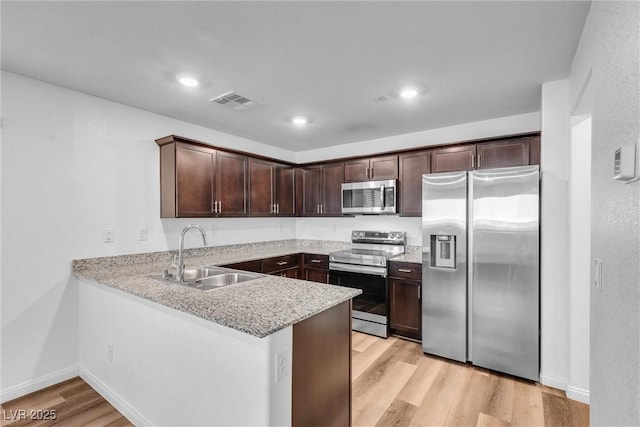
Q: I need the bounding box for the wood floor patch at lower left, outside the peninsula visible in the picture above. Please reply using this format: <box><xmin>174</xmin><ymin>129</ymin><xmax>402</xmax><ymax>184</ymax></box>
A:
<box><xmin>0</xmin><ymin>377</ymin><xmax>133</xmax><ymax>427</ymax></box>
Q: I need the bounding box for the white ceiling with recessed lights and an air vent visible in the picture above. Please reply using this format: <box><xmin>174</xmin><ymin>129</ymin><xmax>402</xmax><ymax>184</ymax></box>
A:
<box><xmin>1</xmin><ymin>1</ymin><xmax>590</xmax><ymax>151</ymax></box>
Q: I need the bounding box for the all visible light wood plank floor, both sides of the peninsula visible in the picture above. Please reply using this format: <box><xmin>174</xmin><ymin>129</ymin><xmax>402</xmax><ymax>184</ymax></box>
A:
<box><xmin>0</xmin><ymin>332</ymin><xmax>589</xmax><ymax>427</ymax></box>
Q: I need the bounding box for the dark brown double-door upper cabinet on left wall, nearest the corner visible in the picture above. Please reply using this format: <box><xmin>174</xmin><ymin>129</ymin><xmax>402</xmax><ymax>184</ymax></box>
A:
<box><xmin>249</xmin><ymin>158</ymin><xmax>295</xmax><ymax>216</ymax></box>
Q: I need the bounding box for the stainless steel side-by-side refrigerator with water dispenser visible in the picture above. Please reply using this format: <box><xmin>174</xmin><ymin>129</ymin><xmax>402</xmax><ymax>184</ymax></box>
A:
<box><xmin>422</xmin><ymin>166</ymin><xmax>540</xmax><ymax>381</ymax></box>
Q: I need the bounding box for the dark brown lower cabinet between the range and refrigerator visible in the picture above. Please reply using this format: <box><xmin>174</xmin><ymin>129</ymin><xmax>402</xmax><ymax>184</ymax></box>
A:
<box><xmin>389</xmin><ymin>262</ymin><xmax>422</xmax><ymax>340</ymax></box>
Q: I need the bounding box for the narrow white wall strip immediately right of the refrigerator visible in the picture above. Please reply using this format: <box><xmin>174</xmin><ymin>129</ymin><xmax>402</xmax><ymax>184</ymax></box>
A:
<box><xmin>540</xmin><ymin>80</ymin><xmax>570</xmax><ymax>390</ymax></box>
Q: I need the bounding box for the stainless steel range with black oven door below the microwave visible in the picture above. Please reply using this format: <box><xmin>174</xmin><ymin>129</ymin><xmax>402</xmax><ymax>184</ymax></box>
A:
<box><xmin>329</xmin><ymin>230</ymin><xmax>407</xmax><ymax>338</ymax></box>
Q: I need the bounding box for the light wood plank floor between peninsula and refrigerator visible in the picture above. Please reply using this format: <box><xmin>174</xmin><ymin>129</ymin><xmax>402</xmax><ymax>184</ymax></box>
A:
<box><xmin>352</xmin><ymin>332</ymin><xmax>589</xmax><ymax>427</ymax></box>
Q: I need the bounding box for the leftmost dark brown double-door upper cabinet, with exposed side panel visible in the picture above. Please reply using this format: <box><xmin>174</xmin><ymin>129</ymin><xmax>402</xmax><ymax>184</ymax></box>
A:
<box><xmin>156</xmin><ymin>136</ymin><xmax>249</xmax><ymax>218</ymax></box>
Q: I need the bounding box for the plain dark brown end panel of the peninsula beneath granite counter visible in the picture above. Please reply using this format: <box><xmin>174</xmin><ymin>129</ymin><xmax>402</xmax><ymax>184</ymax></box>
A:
<box><xmin>291</xmin><ymin>300</ymin><xmax>351</xmax><ymax>427</ymax></box>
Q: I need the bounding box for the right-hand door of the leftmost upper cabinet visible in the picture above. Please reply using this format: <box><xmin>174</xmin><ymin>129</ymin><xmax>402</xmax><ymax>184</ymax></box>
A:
<box><xmin>215</xmin><ymin>151</ymin><xmax>249</xmax><ymax>216</ymax></box>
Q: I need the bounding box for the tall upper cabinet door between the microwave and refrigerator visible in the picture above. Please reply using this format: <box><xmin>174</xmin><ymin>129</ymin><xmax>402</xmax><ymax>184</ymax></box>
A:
<box><xmin>398</xmin><ymin>151</ymin><xmax>431</xmax><ymax>216</ymax></box>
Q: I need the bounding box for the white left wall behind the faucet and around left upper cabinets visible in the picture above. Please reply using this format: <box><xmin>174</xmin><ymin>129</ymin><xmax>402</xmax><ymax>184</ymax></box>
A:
<box><xmin>0</xmin><ymin>72</ymin><xmax>296</xmax><ymax>401</ymax></box>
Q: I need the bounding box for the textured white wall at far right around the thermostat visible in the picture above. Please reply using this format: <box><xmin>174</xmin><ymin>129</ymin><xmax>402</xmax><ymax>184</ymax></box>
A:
<box><xmin>569</xmin><ymin>2</ymin><xmax>640</xmax><ymax>425</ymax></box>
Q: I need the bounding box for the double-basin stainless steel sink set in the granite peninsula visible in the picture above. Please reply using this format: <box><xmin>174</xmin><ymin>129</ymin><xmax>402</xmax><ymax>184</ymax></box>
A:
<box><xmin>150</xmin><ymin>266</ymin><xmax>264</xmax><ymax>291</ymax></box>
